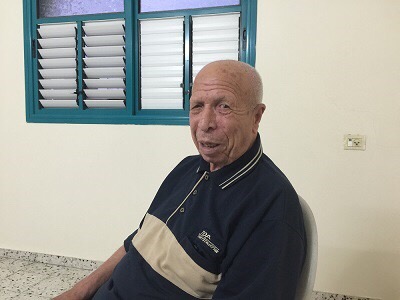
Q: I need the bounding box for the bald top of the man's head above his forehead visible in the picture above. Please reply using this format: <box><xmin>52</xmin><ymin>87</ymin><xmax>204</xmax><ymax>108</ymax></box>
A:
<box><xmin>194</xmin><ymin>60</ymin><xmax>263</xmax><ymax>106</ymax></box>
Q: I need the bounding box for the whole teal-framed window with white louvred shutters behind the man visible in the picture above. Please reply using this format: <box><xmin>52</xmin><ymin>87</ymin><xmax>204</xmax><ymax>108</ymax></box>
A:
<box><xmin>24</xmin><ymin>0</ymin><xmax>256</xmax><ymax>124</ymax></box>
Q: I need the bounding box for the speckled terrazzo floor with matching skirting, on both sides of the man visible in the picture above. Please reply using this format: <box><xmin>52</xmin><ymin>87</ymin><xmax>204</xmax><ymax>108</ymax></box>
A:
<box><xmin>0</xmin><ymin>255</ymin><xmax>372</xmax><ymax>300</ymax></box>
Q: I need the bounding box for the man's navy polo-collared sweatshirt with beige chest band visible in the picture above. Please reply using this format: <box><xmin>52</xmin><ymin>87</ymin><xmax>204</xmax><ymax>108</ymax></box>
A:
<box><xmin>93</xmin><ymin>136</ymin><xmax>306</xmax><ymax>300</ymax></box>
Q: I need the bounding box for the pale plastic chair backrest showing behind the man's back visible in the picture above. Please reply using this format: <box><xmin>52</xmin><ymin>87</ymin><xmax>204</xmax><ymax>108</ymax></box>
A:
<box><xmin>295</xmin><ymin>196</ymin><xmax>318</xmax><ymax>300</ymax></box>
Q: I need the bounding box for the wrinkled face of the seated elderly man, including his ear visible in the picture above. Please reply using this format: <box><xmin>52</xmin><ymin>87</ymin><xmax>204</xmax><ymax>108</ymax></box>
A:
<box><xmin>190</xmin><ymin>68</ymin><xmax>264</xmax><ymax>171</ymax></box>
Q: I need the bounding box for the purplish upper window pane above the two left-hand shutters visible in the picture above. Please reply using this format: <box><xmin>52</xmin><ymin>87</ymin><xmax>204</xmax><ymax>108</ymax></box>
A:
<box><xmin>38</xmin><ymin>0</ymin><xmax>124</xmax><ymax>18</ymax></box>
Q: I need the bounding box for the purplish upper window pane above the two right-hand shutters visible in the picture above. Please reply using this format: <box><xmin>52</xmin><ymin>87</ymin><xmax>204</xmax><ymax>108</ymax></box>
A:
<box><xmin>140</xmin><ymin>0</ymin><xmax>240</xmax><ymax>12</ymax></box>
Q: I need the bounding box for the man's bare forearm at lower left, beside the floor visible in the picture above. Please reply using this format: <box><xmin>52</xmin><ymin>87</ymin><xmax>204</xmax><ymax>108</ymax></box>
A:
<box><xmin>54</xmin><ymin>246</ymin><xmax>126</xmax><ymax>300</ymax></box>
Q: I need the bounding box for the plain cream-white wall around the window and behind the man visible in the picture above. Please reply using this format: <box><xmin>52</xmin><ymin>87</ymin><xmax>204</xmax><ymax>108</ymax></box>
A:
<box><xmin>0</xmin><ymin>0</ymin><xmax>400</xmax><ymax>300</ymax></box>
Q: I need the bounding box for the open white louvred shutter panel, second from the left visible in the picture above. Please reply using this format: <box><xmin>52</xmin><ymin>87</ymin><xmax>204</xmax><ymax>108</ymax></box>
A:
<box><xmin>83</xmin><ymin>20</ymin><xmax>126</xmax><ymax>108</ymax></box>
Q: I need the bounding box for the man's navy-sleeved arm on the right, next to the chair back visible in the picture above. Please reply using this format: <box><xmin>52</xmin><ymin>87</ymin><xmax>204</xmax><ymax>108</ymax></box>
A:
<box><xmin>213</xmin><ymin>220</ymin><xmax>305</xmax><ymax>300</ymax></box>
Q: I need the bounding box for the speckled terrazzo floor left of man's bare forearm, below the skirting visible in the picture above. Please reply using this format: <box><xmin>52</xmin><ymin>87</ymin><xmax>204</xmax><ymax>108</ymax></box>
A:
<box><xmin>0</xmin><ymin>257</ymin><xmax>91</xmax><ymax>300</ymax></box>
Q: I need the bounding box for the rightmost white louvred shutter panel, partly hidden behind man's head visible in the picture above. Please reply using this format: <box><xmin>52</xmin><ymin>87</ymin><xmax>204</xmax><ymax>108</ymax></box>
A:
<box><xmin>192</xmin><ymin>13</ymin><xmax>240</xmax><ymax>80</ymax></box>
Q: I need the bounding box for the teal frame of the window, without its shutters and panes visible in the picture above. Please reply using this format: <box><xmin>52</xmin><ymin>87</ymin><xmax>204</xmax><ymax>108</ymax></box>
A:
<box><xmin>23</xmin><ymin>0</ymin><xmax>257</xmax><ymax>125</ymax></box>
